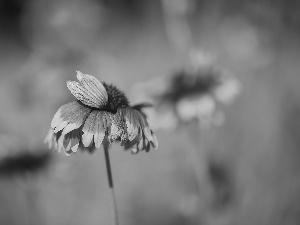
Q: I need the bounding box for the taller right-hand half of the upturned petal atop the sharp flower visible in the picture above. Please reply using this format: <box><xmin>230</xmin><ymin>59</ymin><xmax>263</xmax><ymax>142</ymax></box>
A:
<box><xmin>76</xmin><ymin>71</ymin><xmax>108</xmax><ymax>105</ymax></box>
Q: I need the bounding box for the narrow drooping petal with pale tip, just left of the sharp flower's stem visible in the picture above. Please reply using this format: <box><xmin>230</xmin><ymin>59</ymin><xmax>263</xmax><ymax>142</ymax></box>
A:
<box><xmin>82</xmin><ymin>110</ymin><xmax>97</xmax><ymax>147</ymax></box>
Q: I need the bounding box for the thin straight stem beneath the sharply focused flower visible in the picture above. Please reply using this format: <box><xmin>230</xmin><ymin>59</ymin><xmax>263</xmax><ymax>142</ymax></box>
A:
<box><xmin>104</xmin><ymin>145</ymin><xmax>119</xmax><ymax>225</ymax></box>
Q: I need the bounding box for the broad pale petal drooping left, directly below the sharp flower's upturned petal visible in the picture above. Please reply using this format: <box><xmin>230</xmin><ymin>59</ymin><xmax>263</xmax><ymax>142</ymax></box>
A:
<box><xmin>51</xmin><ymin>101</ymin><xmax>91</xmax><ymax>135</ymax></box>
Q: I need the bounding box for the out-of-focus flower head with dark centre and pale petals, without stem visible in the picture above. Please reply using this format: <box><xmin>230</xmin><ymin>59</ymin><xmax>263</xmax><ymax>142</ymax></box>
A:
<box><xmin>131</xmin><ymin>52</ymin><xmax>241</xmax><ymax>129</ymax></box>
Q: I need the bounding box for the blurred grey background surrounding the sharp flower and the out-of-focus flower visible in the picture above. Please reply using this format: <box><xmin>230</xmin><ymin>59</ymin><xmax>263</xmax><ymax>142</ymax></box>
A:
<box><xmin>0</xmin><ymin>0</ymin><xmax>300</xmax><ymax>225</ymax></box>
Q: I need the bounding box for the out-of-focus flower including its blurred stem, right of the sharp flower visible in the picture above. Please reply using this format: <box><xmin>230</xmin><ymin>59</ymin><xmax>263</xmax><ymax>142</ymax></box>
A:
<box><xmin>134</xmin><ymin>50</ymin><xmax>241</xmax><ymax>221</ymax></box>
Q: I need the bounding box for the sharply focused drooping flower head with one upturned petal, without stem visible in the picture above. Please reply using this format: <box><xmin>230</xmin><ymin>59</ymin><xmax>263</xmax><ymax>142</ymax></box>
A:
<box><xmin>45</xmin><ymin>71</ymin><xmax>157</xmax><ymax>155</ymax></box>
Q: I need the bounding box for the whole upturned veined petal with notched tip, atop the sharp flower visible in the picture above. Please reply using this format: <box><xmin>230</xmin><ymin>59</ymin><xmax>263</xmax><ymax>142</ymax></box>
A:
<box><xmin>67</xmin><ymin>71</ymin><xmax>108</xmax><ymax>108</ymax></box>
